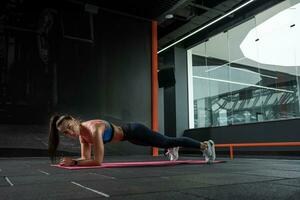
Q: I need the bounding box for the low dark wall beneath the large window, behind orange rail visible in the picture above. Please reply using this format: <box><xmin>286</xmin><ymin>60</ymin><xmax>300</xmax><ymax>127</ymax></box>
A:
<box><xmin>184</xmin><ymin>119</ymin><xmax>300</xmax><ymax>151</ymax></box>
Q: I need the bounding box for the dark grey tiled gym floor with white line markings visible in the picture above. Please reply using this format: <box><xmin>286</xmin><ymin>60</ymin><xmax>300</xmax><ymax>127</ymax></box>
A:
<box><xmin>0</xmin><ymin>156</ymin><xmax>300</xmax><ymax>200</ymax></box>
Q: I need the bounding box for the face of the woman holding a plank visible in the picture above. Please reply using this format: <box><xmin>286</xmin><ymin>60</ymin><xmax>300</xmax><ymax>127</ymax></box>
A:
<box><xmin>57</xmin><ymin>119</ymin><xmax>80</xmax><ymax>138</ymax></box>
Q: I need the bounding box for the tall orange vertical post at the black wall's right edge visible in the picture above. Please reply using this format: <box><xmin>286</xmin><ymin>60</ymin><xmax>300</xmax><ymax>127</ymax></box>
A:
<box><xmin>151</xmin><ymin>21</ymin><xmax>158</xmax><ymax>156</ymax></box>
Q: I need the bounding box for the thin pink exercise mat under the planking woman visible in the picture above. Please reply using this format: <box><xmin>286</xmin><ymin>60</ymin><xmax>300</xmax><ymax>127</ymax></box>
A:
<box><xmin>52</xmin><ymin>160</ymin><xmax>225</xmax><ymax>170</ymax></box>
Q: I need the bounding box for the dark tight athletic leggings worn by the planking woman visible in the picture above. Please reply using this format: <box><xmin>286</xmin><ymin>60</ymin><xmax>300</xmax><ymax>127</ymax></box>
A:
<box><xmin>122</xmin><ymin>123</ymin><xmax>200</xmax><ymax>149</ymax></box>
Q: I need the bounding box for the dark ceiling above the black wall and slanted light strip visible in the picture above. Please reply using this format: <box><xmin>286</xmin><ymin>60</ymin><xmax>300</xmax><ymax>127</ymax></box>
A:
<box><xmin>0</xmin><ymin>0</ymin><xmax>282</xmax><ymax>49</ymax></box>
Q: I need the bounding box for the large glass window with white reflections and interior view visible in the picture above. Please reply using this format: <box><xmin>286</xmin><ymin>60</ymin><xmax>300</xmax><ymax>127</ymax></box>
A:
<box><xmin>188</xmin><ymin>0</ymin><xmax>300</xmax><ymax>128</ymax></box>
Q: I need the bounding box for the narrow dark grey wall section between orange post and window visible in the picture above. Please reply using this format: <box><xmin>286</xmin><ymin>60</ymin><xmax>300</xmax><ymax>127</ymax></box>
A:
<box><xmin>159</xmin><ymin>47</ymin><xmax>188</xmax><ymax>137</ymax></box>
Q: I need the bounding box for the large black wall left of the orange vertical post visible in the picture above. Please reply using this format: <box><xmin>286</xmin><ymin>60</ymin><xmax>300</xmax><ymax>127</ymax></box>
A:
<box><xmin>0</xmin><ymin>1</ymin><xmax>151</xmax><ymax>125</ymax></box>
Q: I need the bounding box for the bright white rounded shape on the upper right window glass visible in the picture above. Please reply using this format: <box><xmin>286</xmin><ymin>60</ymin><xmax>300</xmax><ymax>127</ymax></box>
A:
<box><xmin>240</xmin><ymin>3</ymin><xmax>300</xmax><ymax>66</ymax></box>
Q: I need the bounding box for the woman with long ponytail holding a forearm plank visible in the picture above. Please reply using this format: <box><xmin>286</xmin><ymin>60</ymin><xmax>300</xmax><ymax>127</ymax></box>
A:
<box><xmin>48</xmin><ymin>115</ymin><xmax>216</xmax><ymax>166</ymax></box>
